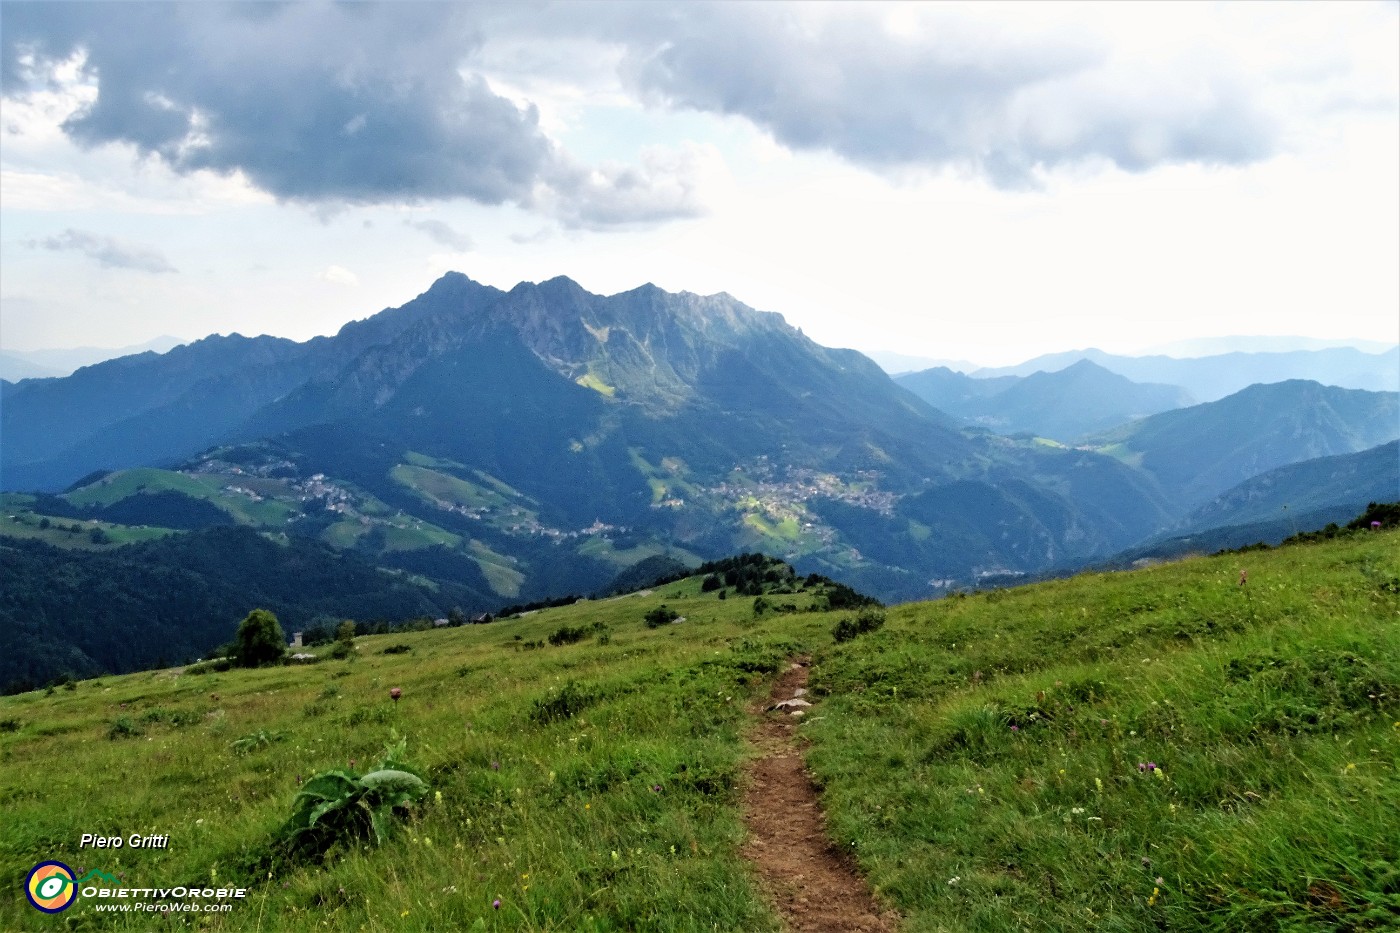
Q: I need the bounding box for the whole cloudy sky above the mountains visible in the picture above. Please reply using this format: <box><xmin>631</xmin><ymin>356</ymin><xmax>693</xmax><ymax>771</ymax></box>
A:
<box><xmin>0</xmin><ymin>1</ymin><xmax>1400</xmax><ymax>366</ymax></box>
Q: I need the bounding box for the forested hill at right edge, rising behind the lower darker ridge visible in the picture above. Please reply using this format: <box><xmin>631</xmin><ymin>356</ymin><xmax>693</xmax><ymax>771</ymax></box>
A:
<box><xmin>1093</xmin><ymin>380</ymin><xmax>1400</xmax><ymax>510</ymax></box>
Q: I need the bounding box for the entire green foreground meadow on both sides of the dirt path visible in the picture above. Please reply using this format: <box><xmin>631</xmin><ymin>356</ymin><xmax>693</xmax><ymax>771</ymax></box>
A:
<box><xmin>0</xmin><ymin>531</ymin><xmax>1400</xmax><ymax>933</ymax></box>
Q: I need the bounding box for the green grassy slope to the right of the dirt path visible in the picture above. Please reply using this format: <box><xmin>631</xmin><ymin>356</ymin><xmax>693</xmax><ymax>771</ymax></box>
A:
<box><xmin>806</xmin><ymin>534</ymin><xmax>1400</xmax><ymax>930</ymax></box>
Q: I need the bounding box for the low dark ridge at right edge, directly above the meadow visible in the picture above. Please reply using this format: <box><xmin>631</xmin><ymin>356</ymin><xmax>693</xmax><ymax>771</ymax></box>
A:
<box><xmin>1175</xmin><ymin>441</ymin><xmax>1400</xmax><ymax>534</ymax></box>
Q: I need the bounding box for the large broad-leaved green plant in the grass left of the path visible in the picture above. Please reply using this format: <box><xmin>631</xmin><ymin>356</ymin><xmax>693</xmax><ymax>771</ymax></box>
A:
<box><xmin>279</xmin><ymin>738</ymin><xmax>428</xmax><ymax>856</ymax></box>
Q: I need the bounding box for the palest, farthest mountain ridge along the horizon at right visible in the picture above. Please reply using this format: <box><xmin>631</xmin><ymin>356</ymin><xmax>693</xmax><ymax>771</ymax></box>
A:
<box><xmin>973</xmin><ymin>347</ymin><xmax>1400</xmax><ymax>402</ymax></box>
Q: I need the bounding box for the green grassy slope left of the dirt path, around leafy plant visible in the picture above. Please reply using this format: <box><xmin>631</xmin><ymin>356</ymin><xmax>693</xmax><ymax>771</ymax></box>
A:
<box><xmin>0</xmin><ymin>580</ymin><xmax>834</xmax><ymax>930</ymax></box>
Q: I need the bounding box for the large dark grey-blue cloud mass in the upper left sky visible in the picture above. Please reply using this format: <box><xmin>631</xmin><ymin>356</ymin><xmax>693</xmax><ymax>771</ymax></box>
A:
<box><xmin>3</xmin><ymin>3</ymin><xmax>699</xmax><ymax>226</ymax></box>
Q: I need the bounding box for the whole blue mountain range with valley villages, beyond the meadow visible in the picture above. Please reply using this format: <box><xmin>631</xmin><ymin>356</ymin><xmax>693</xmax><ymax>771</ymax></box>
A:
<box><xmin>0</xmin><ymin>273</ymin><xmax>1400</xmax><ymax>622</ymax></box>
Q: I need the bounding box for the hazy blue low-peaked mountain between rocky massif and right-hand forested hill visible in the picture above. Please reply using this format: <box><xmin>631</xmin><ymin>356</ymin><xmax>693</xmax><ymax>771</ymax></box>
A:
<box><xmin>895</xmin><ymin>360</ymin><xmax>1194</xmax><ymax>443</ymax></box>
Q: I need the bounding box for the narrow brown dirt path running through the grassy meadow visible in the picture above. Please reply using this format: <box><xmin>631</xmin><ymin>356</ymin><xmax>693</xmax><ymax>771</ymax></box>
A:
<box><xmin>743</xmin><ymin>660</ymin><xmax>899</xmax><ymax>933</ymax></box>
